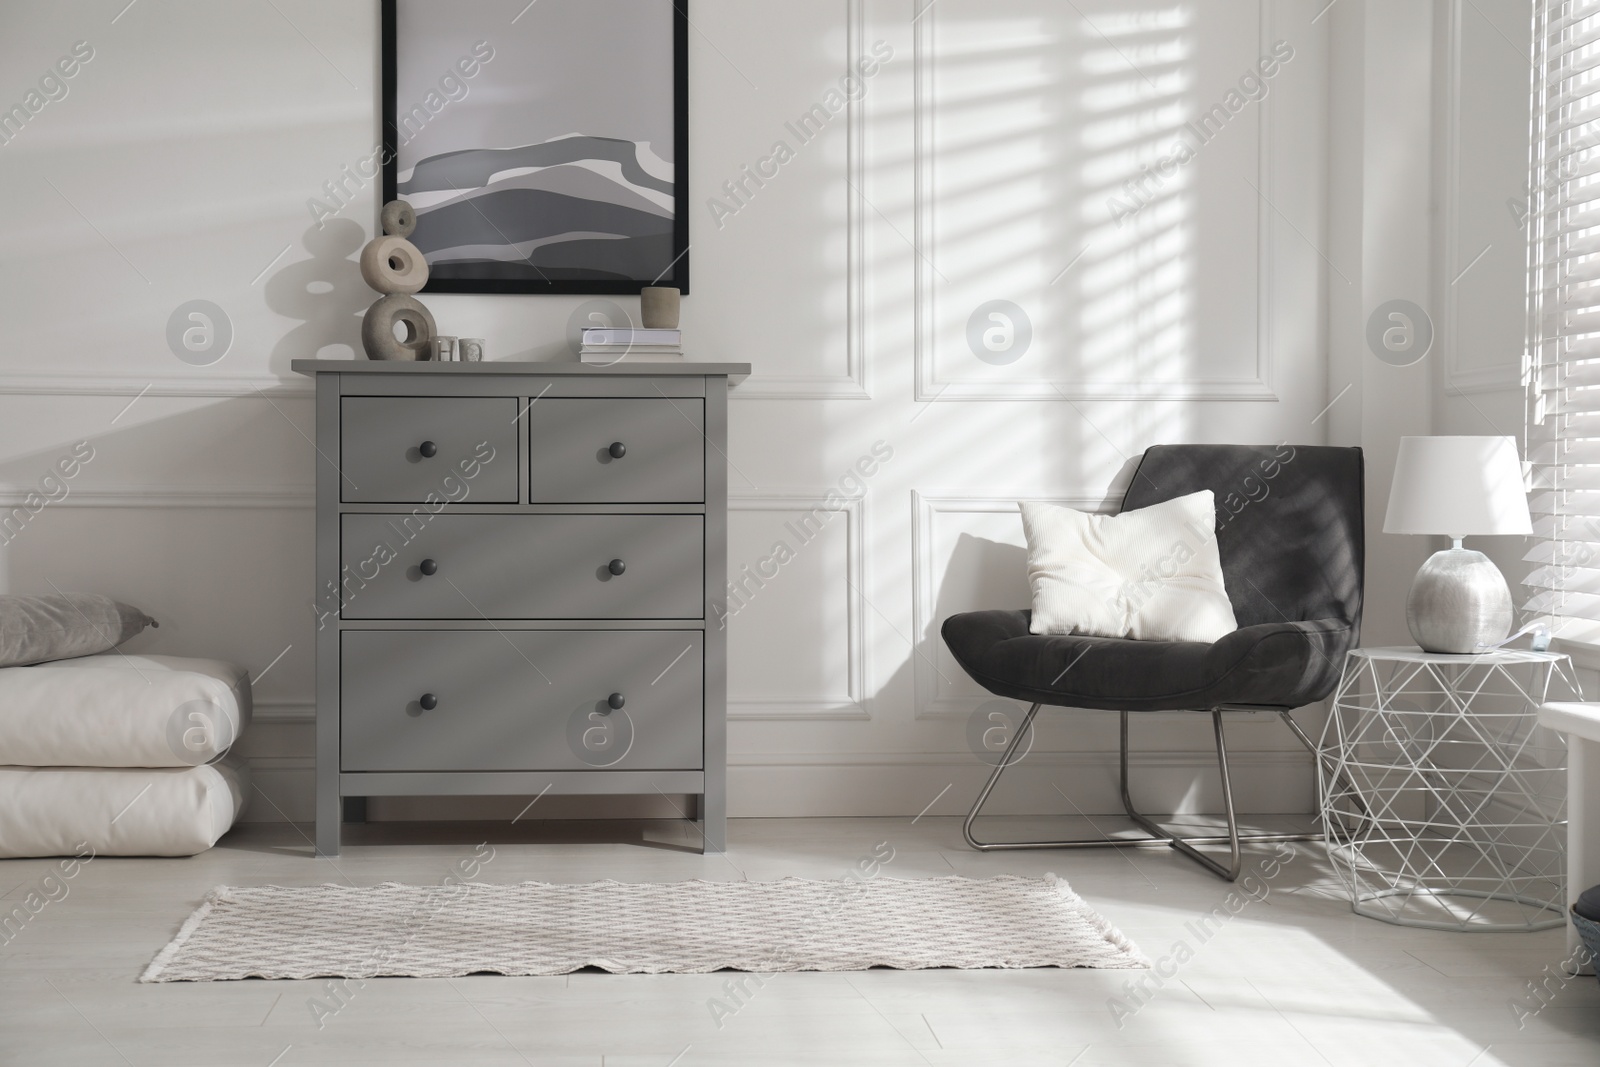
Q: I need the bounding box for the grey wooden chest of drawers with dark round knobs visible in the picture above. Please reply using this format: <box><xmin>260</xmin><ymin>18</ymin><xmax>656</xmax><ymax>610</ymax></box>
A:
<box><xmin>293</xmin><ymin>360</ymin><xmax>749</xmax><ymax>856</ymax></box>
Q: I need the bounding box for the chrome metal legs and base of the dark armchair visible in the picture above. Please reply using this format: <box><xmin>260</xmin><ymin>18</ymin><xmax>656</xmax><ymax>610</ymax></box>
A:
<box><xmin>962</xmin><ymin>704</ymin><xmax>1350</xmax><ymax>881</ymax></box>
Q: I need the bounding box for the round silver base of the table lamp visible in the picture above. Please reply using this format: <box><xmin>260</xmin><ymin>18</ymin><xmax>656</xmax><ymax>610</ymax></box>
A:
<box><xmin>1405</xmin><ymin>549</ymin><xmax>1512</xmax><ymax>654</ymax></box>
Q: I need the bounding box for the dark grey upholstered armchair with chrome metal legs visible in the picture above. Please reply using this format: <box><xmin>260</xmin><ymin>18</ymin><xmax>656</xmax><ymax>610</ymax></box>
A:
<box><xmin>942</xmin><ymin>445</ymin><xmax>1365</xmax><ymax>881</ymax></box>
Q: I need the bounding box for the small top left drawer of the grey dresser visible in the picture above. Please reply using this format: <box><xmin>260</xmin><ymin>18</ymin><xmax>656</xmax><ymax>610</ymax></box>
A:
<box><xmin>339</xmin><ymin>397</ymin><xmax>518</xmax><ymax>504</ymax></box>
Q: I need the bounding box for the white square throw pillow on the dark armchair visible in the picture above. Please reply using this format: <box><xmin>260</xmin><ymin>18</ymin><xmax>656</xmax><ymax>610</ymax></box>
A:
<box><xmin>1022</xmin><ymin>490</ymin><xmax>1238</xmax><ymax>641</ymax></box>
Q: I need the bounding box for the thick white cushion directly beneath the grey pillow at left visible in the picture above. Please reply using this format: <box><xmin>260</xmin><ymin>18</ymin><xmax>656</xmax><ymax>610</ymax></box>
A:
<box><xmin>0</xmin><ymin>651</ymin><xmax>250</xmax><ymax>768</ymax></box>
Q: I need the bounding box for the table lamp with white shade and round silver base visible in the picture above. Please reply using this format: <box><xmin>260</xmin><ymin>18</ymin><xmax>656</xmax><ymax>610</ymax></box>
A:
<box><xmin>1384</xmin><ymin>437</ymin><xmax>1533</xmax><ymax>654</ymax></box>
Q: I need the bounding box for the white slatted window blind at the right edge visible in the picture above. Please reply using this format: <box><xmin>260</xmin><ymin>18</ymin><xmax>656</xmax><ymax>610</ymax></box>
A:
<box><xmin>1523</xmin><ymin>0</ymin><xmax>1600</xmax><ymax>643</ymax></box>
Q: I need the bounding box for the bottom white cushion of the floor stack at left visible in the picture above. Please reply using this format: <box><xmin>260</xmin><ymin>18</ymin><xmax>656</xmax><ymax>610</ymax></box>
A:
<box><xmin>0</xmin><ymin>758</ymin><xmax>250</xmax><ymax>859</ymax></box>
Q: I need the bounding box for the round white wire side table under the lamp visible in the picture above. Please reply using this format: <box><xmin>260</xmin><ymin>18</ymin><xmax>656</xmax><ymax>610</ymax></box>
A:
<box><xmin>1317</xmin><ymin>648</ymin><xmax>1582</xmax><ymax>931</ymax></box>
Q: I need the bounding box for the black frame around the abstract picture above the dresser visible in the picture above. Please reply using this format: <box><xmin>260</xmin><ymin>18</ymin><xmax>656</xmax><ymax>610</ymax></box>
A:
<box><xmin>381</xmin><ymin>0</ymin><xmax>690</xmax><ymax>296</ymax></box>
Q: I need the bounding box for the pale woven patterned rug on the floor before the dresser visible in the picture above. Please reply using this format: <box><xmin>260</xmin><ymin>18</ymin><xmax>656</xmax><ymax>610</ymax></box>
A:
<box><xmin>142</xmin><ymin>875</ymin><xmax>1146</xmax><ymax>982</ymax></box>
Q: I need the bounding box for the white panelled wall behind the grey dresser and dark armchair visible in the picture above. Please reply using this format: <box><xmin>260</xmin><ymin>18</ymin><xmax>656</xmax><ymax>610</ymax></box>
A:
<box><xmin>0</xmin><ymin>0</ymin><xmax>1401</xmax><ymax>817</ymax></box>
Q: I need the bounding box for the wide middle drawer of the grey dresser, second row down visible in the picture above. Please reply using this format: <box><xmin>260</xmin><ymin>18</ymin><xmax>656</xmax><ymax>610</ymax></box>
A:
<box><xmin>339</xmin><ymin>512</ymin><xmax>706</xmax><ymax>619</ymax></box>
